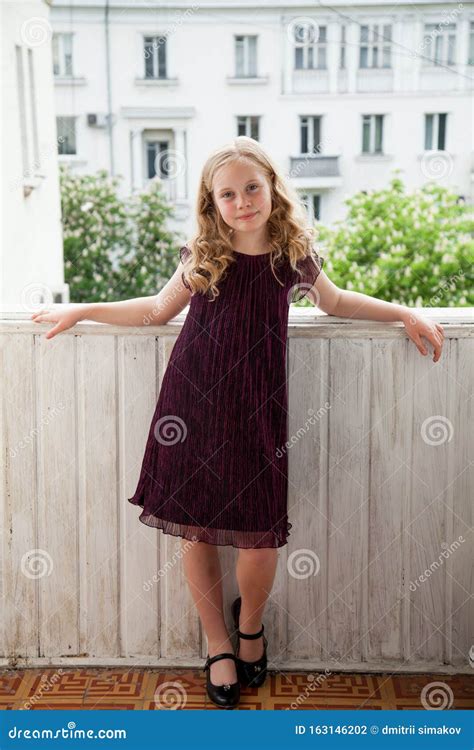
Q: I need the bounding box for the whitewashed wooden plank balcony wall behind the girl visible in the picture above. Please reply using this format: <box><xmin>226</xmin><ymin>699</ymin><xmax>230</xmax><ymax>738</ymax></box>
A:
<box><xmin>0</xmin><ymin>308</ymin><xmax>474</xmax><ymax>672</ymax></box>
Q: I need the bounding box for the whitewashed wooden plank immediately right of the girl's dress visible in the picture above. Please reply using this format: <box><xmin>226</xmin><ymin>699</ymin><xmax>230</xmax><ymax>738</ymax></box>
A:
<box><xmin>286</xmin><ymin>339</ymin><xmax>330</xmax><ymax>660</ymax></box>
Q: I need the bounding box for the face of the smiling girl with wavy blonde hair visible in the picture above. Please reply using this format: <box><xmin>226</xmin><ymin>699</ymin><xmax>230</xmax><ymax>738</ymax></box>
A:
<box><xmin>212</xmin><ymin>160</ymin><xmax>272</xmax><ymax>234</ymax></box>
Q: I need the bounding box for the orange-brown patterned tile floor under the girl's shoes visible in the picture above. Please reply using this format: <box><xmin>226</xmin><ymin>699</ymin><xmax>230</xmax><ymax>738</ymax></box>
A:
<box><xmin>0</xmin><ymin>667</ymin><xmax>474</xmax><ymax>711</ymax></box>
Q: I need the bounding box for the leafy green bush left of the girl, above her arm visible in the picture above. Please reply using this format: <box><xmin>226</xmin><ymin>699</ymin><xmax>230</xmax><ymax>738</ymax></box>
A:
<box><xmin>60</xmin><ymin>166</ymin><xmax>179</xmax><ymax>302</ymax></box>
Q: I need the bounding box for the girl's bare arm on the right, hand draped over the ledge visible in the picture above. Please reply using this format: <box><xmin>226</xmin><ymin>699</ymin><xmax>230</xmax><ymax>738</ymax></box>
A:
<box><xmin>311</xmin><ymin>271</ymin><xmax>444</xmax><ymax>362</ymax></box>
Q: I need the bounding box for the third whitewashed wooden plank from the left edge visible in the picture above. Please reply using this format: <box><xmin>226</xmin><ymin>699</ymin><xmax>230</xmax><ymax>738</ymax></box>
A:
<box><xmin>78</xmin><ymin>335</ymin><xmax>121</xmax><ymax>656</ymax></box>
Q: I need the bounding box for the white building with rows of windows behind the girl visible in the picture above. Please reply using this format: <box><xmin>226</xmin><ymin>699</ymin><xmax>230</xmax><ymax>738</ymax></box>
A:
<box><xmin>52</xmin><ymin>0</ymin><xmax>474</xmax><ymax>236</ymax></box>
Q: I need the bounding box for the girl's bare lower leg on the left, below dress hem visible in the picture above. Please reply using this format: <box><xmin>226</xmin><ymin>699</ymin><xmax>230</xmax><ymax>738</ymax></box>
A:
<box><xmin>182</xmin><ymin>539</ymin><xmax>237</xmax><ymax>685</ymax></box>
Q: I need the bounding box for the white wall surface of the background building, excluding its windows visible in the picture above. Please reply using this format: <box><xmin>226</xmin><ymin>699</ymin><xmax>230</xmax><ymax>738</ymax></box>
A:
<box><xmin>52</xmin><ymin>0</ymin><xmax>474</xmax><ymax>231</ymax></box>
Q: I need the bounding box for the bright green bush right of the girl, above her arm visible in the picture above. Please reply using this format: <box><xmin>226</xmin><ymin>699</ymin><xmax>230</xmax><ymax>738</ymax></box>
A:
<box><xmin>317</xmin><ymin>177</ymin><xmax>474</xmax><ymax>307</ymax></box>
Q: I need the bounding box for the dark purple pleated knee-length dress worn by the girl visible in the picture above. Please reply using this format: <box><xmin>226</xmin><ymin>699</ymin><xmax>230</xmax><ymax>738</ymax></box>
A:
<box><xmin>129</xmin><ymin>245</ymin><xmax>324</xmax><ymax>549</ymax></box>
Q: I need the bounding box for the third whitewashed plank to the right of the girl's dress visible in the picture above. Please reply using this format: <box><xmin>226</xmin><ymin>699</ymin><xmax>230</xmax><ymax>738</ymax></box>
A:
<box><xmin>363</xmin><ymin>340</ymin><xmax>413</xmax><ymax>661</ymax></box>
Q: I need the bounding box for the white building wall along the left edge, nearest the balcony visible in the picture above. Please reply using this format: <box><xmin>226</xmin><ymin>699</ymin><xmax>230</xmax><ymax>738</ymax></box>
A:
<box><xmin>0</xmin><ymin>0</ymin><xmax>69</xmax><ymax>308</ymax></box>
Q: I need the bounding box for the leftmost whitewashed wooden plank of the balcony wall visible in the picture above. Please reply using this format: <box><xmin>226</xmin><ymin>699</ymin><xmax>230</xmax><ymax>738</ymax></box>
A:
<box><xmin>1</xmin><ymin>334</ymin><xmax>38</xmax><ymax>662</ymax></box>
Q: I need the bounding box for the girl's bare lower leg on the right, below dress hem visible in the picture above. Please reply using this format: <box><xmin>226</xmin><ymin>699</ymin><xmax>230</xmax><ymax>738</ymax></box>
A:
<box><xmin>236</xmin><ymin>548</ymin><xmax>278</xmax><ymax>661</ymax></box>
